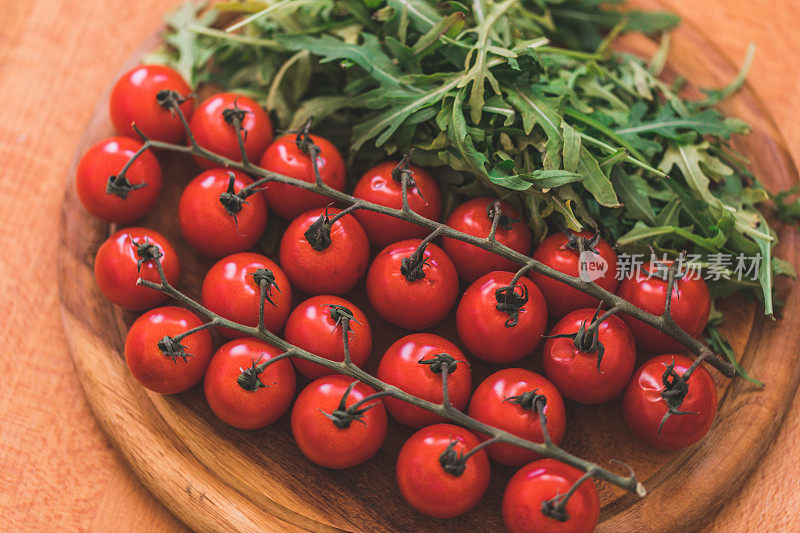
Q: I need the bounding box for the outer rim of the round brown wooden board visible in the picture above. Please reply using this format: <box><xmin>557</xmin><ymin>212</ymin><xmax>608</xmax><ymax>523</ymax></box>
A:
<box><xmin>59</xmin><ymin>4</ymin><xmax>800</xmax><ymax>531</ymax></box>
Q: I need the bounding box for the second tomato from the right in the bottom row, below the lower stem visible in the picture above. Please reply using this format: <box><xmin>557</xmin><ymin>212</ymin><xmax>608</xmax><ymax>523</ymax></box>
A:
<box><xmin>396</xmin><ymin>424</ymin><xmax>490</xmax><ymax>518</ymax></box>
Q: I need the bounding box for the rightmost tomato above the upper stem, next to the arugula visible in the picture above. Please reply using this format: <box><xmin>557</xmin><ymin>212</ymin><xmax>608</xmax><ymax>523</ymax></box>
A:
<box><xmin>617</xmin><ymin>263</ymin><xmax>711</xmax><ymax>352</ymax></box>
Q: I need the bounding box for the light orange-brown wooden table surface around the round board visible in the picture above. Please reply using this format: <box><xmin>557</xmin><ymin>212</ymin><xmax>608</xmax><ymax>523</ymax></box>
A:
<box><xmin>0</xmin><ymin>0</ymin><xmax>800</xmax><ymax>531</ymax></box>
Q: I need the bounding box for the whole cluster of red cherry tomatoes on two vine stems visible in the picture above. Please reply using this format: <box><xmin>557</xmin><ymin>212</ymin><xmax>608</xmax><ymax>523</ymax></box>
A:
<box><xmin>77</xmin><ymin>65</ymin><xmax>716</xmax><ymax>531</ymax></box>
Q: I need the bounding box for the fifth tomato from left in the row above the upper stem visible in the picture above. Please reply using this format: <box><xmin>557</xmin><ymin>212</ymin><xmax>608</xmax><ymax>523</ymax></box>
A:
<box><xmin>442</xmin><ymin>198</ymin><xmax>531</xmax><ymax>283</ymax></box>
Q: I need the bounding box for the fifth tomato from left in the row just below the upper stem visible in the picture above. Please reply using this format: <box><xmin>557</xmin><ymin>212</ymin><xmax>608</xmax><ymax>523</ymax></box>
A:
<box><xmin>456</xmin><ymin>272</ymin><xmax>547</xmax><ymax>364</ymax></box>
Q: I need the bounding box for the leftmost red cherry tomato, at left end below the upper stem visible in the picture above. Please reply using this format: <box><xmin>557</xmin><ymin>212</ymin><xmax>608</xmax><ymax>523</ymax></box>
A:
<box><xmin>75</xmin><ymin>137</ymin><xmax>162</xmax><ymax>224</ymax></box>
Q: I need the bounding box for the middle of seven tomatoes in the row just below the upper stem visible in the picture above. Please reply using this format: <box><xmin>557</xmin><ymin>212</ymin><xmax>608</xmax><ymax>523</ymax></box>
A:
<box><xmin>367</xmin><ymin>239</ymin><xmax>458</xmax><ymax>330</ymax></box>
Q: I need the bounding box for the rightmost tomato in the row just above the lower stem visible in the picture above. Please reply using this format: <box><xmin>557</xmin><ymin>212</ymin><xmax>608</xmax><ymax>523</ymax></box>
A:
<box><xmin>469</xmin><ymin>368</ymin><xmax>567</xmax><ymax>466</ymax></box>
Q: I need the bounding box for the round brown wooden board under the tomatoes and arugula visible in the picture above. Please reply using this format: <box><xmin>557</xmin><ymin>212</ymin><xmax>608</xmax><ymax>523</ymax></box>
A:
<box><xmin>59</xmin><ymin>0</ymin><xmax>800</xmax><ymax>531</ymax></box>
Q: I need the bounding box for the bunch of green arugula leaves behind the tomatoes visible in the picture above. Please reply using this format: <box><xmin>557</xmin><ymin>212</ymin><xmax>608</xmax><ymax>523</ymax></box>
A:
<box><xmin>151</xmin><ymin>0</ymin><xmax>793</xmax><ymax>362</ymax></box>
